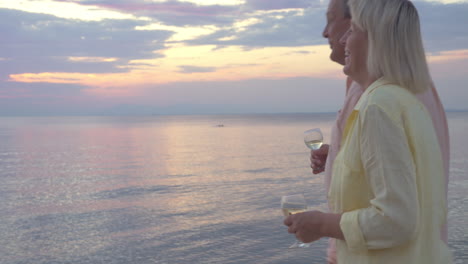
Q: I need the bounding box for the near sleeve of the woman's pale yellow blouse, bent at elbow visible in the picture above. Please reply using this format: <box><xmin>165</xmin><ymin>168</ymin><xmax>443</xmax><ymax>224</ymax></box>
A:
<box><xmin>350</xmin><ymin>102</ymin><xmax>419</xmax><ymax>251</ymax></box>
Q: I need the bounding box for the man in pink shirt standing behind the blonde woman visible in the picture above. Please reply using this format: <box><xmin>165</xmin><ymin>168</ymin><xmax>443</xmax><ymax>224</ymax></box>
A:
<box><xmin>310</xmin><ymin>0</ymin><xmax>450</xmax><ymax>263</ymax></box>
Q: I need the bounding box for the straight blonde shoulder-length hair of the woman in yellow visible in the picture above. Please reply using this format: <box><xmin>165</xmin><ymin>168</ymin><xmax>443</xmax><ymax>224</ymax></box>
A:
<box><xmin>349</xmin><ymin>0</ymin><xmax>431</xmax><ymax>93</ymax></box>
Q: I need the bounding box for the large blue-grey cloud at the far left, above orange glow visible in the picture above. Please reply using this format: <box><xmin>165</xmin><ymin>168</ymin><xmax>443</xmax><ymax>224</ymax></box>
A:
<box><xmin>0</xmin><ymin>9</ymin><xmax>172</xmax><ymax>78</ymax></box>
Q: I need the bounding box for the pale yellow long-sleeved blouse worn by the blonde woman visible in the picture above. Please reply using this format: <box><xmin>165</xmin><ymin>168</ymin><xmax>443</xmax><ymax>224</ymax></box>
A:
<box><xmin>329</xmin><ymin>79</ymin><xmax>452</xmax><ymax>264</ymax></box>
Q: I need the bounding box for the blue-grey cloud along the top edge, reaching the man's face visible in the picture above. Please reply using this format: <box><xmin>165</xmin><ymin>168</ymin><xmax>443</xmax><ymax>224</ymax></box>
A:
<box><xmin>59</xmin><ymin>0</ymin><xmax>326</xmax><ymax>47</ymax></box>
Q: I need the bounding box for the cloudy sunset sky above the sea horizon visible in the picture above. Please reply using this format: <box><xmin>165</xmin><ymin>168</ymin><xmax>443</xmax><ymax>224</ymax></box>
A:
<box><xmin>0</xmin><ymin>0</ymin><xmax>468</xmax><ymax>116</ymax></box>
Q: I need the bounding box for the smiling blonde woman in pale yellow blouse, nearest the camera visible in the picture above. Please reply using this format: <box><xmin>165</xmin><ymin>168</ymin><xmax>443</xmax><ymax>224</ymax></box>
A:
<box><xmin>284</xmin><ymin>0</ymin><xmax>452</xmax><ymax>264</ymax></box>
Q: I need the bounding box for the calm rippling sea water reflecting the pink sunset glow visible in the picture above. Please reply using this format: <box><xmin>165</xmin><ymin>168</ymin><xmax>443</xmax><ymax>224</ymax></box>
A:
<box><xmin>0</xmin><ymin>113</ymin><xmax>468</xmax><ymax>264</ymax></box>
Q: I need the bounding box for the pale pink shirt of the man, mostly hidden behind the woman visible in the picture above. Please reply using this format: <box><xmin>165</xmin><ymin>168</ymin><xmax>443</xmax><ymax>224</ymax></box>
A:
<box><xmin>324</xmin><ymin>78</ymin><xmax>450</xmax><ymax>263</ymax></box>
